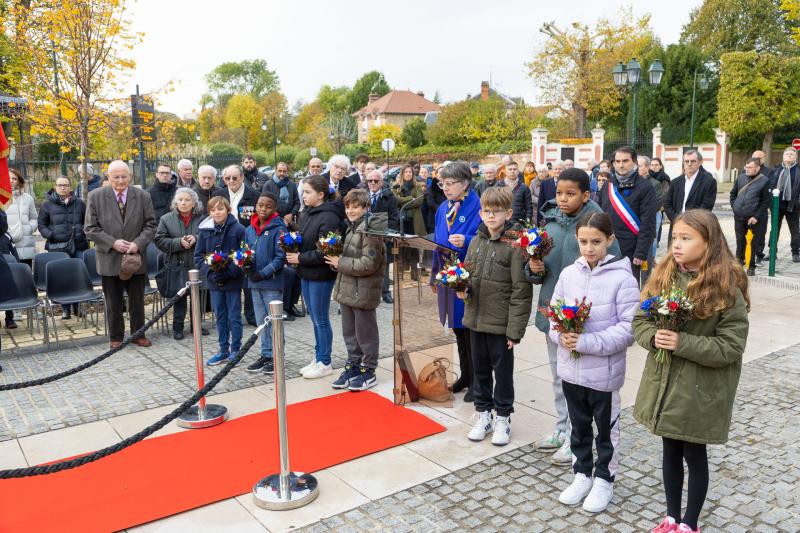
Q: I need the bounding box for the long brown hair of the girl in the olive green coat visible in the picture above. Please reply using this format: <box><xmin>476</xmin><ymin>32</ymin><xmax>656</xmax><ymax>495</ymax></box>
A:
<box><xmin>642</xmin><ymin>209</ymin><xmax>750</xmax><ymax>319</ymax></box>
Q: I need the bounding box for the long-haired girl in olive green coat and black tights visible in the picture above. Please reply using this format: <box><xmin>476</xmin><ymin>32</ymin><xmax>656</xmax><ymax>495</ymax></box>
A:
<box><xmin>633</xmin><ymin>209</ymin><xmax>750</xmax><ymax>533</ymax></box>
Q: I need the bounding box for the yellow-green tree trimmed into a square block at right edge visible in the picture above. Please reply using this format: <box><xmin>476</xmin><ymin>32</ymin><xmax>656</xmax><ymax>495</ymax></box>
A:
<box><xmin>718</xmin><ymin>51</ymin><xmax>800</xmax><ymax>154</ymax></box>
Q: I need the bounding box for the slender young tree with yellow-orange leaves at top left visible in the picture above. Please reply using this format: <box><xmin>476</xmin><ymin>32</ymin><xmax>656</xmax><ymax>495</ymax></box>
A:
<box><xmin>6</xmin><ymin>0</ymin><xmax>142</xmax><ymax>195</ymax></box>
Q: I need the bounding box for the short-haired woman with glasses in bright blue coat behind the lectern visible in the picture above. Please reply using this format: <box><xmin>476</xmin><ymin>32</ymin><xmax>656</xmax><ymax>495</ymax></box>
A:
<box><xmin>431</xmin><ymin>161</ymin><xmax>481</xmax><ymax>402</ymax></box>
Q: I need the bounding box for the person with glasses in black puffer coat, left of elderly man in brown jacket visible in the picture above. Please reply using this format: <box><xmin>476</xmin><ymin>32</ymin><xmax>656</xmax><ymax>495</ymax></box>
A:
<box><xmin>38</xmin><ymin>185</ymin><xmax>89</xmax><ymax>258</ymax></box>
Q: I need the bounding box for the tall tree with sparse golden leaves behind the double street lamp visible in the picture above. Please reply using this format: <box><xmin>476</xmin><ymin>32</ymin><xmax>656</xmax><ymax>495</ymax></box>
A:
<box><xmin>527</xmin><ymin>8</ymin><xmax>655</xmax><ymax>135</ymax></box>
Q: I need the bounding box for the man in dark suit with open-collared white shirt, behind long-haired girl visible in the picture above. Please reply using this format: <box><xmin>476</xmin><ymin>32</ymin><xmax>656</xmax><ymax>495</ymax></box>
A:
<box><xmin>664</xmin><ymin>150</ymin><xmax>717</xmax><ymax>242</ymax></box>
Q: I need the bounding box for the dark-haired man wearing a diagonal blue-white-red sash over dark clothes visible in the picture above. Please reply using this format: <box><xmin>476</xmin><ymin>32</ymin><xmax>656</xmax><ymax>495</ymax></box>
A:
<box><xmin>600</xmin><ymin>146</ymin><xmax>657</xmax><ymax>281</ymax></box>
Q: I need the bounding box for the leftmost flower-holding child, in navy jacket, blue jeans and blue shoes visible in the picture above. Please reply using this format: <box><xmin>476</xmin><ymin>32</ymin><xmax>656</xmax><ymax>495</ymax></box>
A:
<box><xmin>194</xmin><ymin>196</ymin><xmax>244</xmax><ymax>366</ymax></box>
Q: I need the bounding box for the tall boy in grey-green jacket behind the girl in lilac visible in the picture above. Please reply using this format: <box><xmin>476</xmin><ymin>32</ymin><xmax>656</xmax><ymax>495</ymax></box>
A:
<box><xmin>525</xmin><ymin>168</ymin><xmax>620</xmax><ymax>465</ymax></box>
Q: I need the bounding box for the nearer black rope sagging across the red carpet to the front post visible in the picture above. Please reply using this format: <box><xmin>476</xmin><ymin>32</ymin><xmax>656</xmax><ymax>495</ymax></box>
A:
<box><xmin>0</xmin><ymin>332</ymin><xmax>260</xmax><ymax>479</ymax></box>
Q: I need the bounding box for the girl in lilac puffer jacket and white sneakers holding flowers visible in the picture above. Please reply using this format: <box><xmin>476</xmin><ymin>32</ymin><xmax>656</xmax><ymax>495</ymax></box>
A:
<box><xmin>549</xmin><ymin>213</ymin><xmax>639</xmax><ymax>513</ymax></box>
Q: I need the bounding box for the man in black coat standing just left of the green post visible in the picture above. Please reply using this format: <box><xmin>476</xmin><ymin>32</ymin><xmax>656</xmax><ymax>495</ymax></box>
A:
<box><xmin>730</xmin><ymin>157</ymin><xmax>772</xmax><ymax>276</ymax></box>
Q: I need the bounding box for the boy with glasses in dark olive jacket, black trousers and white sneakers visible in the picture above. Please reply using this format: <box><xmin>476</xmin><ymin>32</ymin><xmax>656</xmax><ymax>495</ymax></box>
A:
<box><xmin>456</xmin><ymin>187</ymin><xmax>533</xmax><ymax>446</ymax></box>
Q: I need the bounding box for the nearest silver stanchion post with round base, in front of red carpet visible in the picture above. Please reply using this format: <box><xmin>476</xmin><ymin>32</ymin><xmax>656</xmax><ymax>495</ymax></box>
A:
<box><xmin>253</xmin><ymin>300</ymin><xmax>319</xmax><ymax>511</ymax></box>
